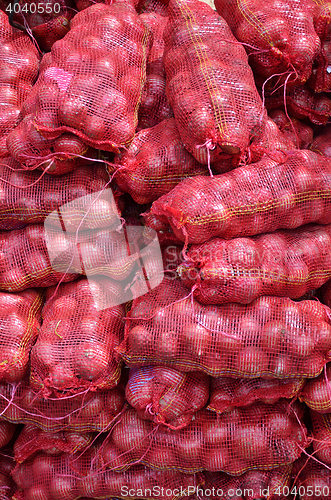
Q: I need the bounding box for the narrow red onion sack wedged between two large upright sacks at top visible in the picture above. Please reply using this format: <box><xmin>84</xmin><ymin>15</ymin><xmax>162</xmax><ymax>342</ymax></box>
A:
<box><xmin>138</xmin><ymin>13</ymin><xmax>173</xmax><ymax>130</ymax></box>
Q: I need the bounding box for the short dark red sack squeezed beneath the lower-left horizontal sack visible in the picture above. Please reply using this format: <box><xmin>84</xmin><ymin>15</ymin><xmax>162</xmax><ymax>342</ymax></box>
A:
<box><xmin>14</xmin><ymin>424</ymin><xmax>93</xmax><ymax>463</ymax></box>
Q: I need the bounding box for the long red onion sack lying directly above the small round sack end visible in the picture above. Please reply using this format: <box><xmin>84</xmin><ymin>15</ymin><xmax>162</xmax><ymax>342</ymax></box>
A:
<box><xmin>117</xmin><ymin>278</ymin><xmax>331</xmax><ymax>379</ymax></box>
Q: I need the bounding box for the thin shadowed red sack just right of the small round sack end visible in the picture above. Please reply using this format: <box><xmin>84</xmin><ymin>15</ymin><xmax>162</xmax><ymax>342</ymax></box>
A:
<box><xmin>207</xmin><ymin>377</ymin><xmax>305</xmax><ymax>413</ymax></box>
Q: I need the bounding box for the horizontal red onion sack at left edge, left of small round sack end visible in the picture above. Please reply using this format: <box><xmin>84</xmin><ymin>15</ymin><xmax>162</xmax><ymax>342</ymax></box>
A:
<box><xmin>0</xmin><ymin>382</ymin><xmax>124</xmax><ymax>433</ymax></box>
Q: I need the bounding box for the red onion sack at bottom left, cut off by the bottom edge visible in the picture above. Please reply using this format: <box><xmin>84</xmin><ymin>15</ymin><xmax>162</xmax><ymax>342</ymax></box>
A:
<box><xmin>13</xmin><ymin>456</ymin><xmax>203</xmax><ymax>500</ymax></box>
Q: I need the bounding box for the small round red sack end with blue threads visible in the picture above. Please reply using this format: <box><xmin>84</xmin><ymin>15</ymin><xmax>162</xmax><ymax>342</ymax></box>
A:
<box><xmin>125</xmin><ymin>366</ymin><xmax>209</xmax><ymax>429</ymax></box>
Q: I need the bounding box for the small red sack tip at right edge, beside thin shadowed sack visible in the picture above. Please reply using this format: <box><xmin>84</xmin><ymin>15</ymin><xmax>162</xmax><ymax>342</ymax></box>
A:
<box><xmin>299</xmin><ymin>363</ymin><xmax>331</xmax><ymax>413</ymax></box>
